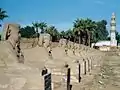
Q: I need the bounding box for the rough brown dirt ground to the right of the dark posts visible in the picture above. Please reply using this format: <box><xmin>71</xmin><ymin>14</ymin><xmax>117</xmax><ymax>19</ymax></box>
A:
<box><xmin>85</xmin><ymin>53</ymin><xmax>120</xmax><ymax>90</ymax></box>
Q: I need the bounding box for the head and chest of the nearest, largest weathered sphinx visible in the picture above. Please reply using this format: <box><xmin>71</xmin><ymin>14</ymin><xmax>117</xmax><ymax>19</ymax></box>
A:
<box><xmin>2</xmin><ymin>24</ymin><xmax>24</xmax><ymax>63</ymax></box>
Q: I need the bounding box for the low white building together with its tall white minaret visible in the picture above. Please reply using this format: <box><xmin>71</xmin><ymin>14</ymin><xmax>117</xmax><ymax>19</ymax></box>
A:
<box><xmin>92</xmin><ymin>13</ymin><xmax>117</xmax><ymax>51</ymax></box>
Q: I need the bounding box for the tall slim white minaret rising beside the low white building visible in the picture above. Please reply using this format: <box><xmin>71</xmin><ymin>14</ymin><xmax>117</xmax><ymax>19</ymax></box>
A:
<box><xmin>110</xmin><ymin>13</ymin><xmax>117</xmax><ymax>46</ymax></box>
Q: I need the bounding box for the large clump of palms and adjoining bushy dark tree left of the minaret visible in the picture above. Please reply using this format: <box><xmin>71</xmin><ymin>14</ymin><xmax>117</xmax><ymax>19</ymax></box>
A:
<box><xmin>73</xmin><ymin>18</ymin><xmax>108</xmax><ymax>45</ymax></box>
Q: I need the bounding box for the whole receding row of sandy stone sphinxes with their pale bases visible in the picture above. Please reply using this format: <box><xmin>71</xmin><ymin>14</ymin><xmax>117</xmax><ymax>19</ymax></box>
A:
<box><xmin>0</xmin><ymin>23</ymin><xmax>104</xmax><ymax>90</ymax></box>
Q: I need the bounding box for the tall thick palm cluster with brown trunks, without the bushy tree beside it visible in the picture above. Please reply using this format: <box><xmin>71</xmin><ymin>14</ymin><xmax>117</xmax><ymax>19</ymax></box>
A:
<box><xmin>73</xmin><ymin>18</ymin><xmax>96</xmax><ymax>45</ymax></box>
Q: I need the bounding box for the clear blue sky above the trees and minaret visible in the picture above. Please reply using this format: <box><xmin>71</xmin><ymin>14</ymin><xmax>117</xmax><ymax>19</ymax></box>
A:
<box><xmin>0</xmin><ymin>0</ymin><xmax>120</xmax><ymax>31</ymax></box>
